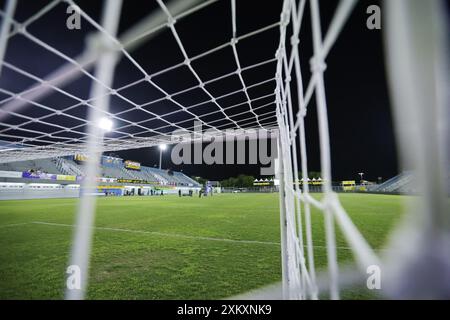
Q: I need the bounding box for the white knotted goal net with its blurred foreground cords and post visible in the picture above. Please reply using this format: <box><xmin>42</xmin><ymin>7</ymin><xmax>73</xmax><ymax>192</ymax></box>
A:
<box><xmin>0</xmin><ymin>0</ymin><xmax>450</xmax><ymax>299</ymax></box>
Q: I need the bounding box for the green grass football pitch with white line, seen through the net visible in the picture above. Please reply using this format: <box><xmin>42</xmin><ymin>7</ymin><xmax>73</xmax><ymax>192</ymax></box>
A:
<box><xmin>0</xmin><ymin>193</ymin><xmax>403</xmax><ymax>299</ymax></box>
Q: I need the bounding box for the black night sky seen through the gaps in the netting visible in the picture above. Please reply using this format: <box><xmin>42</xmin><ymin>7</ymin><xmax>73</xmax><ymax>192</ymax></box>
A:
<box><xmin>0</xmin><ymin>0</ymin><xmax>397</xmax><ymax>180</ymax></box>
